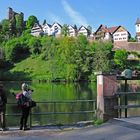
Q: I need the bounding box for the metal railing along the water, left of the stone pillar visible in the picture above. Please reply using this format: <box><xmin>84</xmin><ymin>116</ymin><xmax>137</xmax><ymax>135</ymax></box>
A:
<box><xmin>6</xmin><ymin>100</ymin><xmax>96</xmax><ymax>127</ymax></box>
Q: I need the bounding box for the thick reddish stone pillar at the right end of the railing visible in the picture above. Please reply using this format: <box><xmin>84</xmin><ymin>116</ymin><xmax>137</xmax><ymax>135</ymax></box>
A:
<box><xmin>97</xmin><ymin>74</ymin><xmax>118</xmax><ymax>121</ymax></box>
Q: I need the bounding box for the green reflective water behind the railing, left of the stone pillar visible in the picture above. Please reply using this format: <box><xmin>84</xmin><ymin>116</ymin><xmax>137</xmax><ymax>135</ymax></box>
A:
<box><xmin>5</xmin><ymin>82</ymin><xmax>96</xmax><ymax>126</ymax></box>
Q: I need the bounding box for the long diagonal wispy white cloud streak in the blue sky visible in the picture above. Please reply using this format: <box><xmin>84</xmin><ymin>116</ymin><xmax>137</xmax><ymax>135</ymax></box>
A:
<box><xmin>62</xmin><ymin>0</ymin><xmax>89</xmax><ymax>26</ymax></box>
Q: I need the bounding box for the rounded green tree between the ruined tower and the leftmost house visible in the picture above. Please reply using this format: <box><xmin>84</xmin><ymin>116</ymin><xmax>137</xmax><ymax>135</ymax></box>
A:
<box><xmin>26</xmin><ymin>15</ymin><xmax>39</xmax><ymax>29</ymax></box>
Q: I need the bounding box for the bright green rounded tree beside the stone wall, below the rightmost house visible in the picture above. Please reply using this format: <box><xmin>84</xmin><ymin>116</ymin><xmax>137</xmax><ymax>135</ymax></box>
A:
<box><xmin>114</xmin><ymin>49</ymin><xmax>128</xmax><ymax>69</ymax></box>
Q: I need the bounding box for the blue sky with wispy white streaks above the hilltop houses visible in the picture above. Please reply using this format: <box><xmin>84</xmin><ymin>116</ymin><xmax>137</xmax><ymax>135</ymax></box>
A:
<box><xmin>0</xmin><ymin>0</ymin><xmax>140</xmax><ymax>37</ymax></box>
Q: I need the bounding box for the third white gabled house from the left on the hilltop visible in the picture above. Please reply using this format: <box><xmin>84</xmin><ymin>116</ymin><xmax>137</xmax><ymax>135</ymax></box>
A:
<box><xmin>50</xmin><ymin>22</ymin><xmax>62</xmax><ymax>36</ymax></box>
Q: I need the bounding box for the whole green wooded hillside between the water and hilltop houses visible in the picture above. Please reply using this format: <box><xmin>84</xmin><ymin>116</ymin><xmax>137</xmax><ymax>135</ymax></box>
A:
<box><xmin>0</xmin><ymin>15</ymin><xmax>140</xmax><ymax>81</ymax></box>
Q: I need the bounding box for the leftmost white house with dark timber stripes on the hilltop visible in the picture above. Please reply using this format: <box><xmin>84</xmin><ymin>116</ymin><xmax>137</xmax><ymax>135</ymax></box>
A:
<box><xmin>31</xmin><ymin>23</ymin><xmax>44</xmax><ymax>36</ymax></box>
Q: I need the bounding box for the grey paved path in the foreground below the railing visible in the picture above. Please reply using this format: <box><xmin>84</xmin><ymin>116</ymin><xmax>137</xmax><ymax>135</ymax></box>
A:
<box><xmin>0</xmin><ymin>117</ymin><xmax>140</xmax><ymax>140</ymax></box>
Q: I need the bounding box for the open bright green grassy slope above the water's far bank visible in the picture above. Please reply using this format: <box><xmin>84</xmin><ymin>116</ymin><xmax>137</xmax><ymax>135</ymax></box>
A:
<box><xmin>10</xmin><ymin>57</ymin><xmax>49</xmax><ymax>79</ymax></box>
